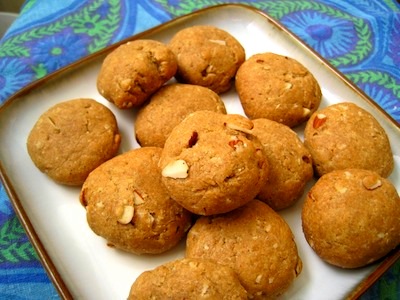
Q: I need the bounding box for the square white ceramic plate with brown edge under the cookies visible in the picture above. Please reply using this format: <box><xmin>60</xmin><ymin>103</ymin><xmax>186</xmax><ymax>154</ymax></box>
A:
<box><xmin>0</xmin><ymin>5</ymin><xmax>400</xmax><ymax>299</ymax></box>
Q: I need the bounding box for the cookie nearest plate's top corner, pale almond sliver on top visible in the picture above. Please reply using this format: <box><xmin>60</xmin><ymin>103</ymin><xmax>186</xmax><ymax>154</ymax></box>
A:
<box><xmin>169</xmin><ymin>25</ymin><xmax>246</xmax><ymax>94</ymax></box>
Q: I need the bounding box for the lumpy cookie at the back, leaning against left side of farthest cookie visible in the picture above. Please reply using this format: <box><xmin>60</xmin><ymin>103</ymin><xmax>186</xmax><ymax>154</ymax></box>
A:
<box><xmin>97</xmin><ymin>40</ymin><xmax>178</xmax><ymax>109</ymax></box>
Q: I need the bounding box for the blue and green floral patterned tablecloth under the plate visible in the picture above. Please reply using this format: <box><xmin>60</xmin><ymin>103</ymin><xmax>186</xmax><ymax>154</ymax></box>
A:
<box><xmin>0</xmin><ymin>0</ymin><xmax>400</xmax><ymax>299</ymax></box>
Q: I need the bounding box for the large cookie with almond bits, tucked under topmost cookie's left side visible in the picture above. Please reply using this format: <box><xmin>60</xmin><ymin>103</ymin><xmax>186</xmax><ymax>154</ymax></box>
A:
<box><xmin>80</xmin><ymin>147</ymin><xmax>191</xmax><ymax>254</ymax></box>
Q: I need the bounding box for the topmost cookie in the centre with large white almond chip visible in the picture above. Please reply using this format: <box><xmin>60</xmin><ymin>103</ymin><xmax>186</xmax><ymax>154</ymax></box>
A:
<box><xmin>160</xmin><ymin>111</ymin><xmax>268</xmax><ymax>215</ymax></box>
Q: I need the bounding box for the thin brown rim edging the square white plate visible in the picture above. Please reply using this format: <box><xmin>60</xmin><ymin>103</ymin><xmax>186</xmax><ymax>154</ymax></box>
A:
<box><xmin>0</xmin><ymin>3</ymin><xmax>400</xmax><ymax>299</ymax></box>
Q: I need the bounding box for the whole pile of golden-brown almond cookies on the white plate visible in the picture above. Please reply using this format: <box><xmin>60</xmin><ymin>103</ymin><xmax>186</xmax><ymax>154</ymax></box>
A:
<box><xmin>28</xmin><ymin>25</ymin><xmax>400</xmax><ymax>299</ymax></box>
